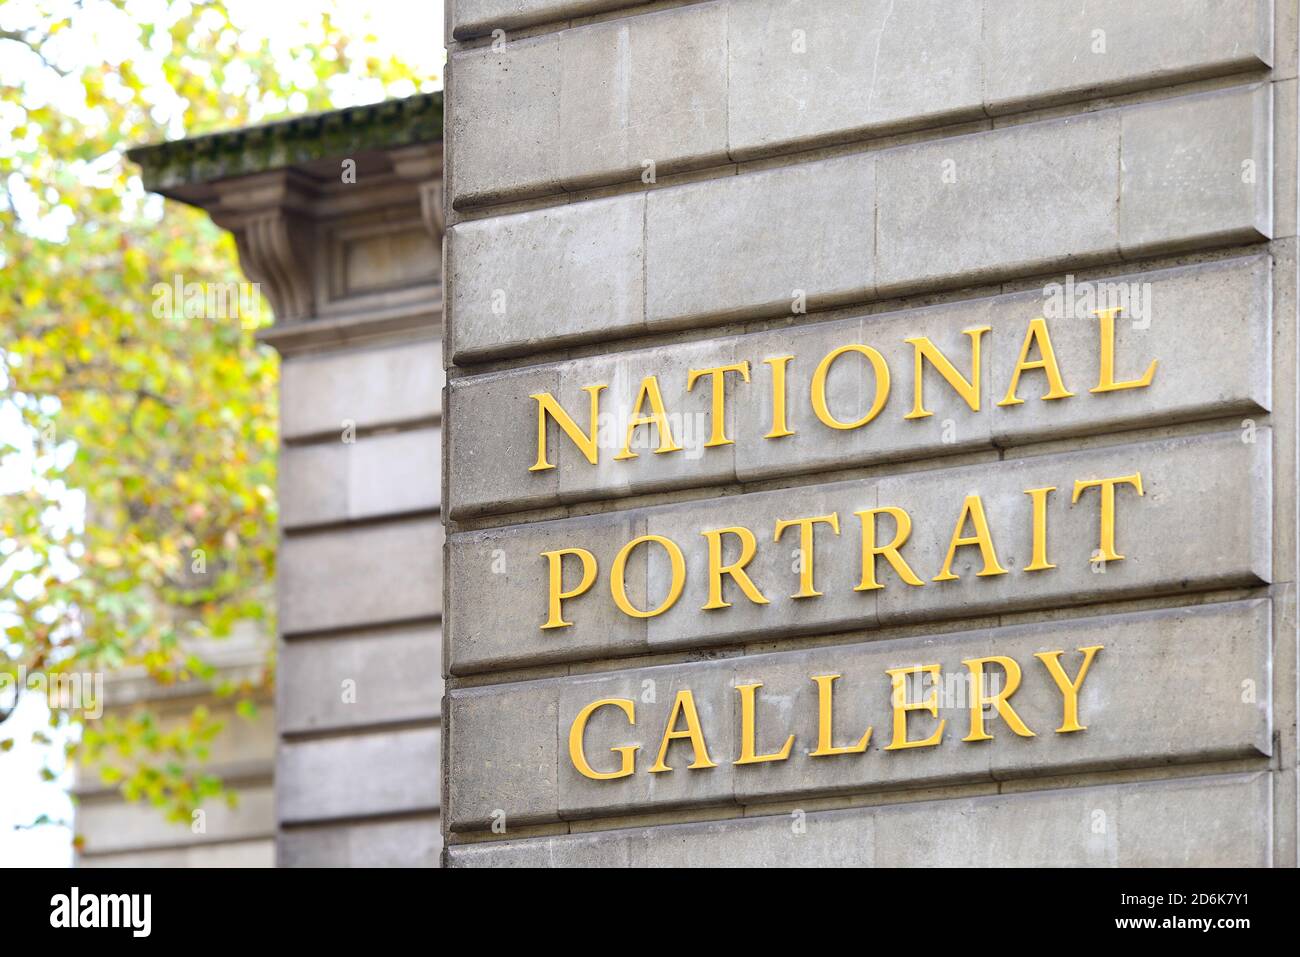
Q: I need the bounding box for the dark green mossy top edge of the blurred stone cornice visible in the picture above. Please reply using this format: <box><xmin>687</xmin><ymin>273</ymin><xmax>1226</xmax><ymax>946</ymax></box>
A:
<box><xmin>126</xmin><ymin>92</ymin><xmax>442</xmax><ymax>194</ymax></box>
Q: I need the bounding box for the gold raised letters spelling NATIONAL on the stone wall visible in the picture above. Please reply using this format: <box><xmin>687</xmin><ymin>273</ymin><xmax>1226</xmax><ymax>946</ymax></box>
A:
<box><xmin>528</xmin><ymin>307</ymin><xmax>1160</xmax><ymax>472</ymax></box>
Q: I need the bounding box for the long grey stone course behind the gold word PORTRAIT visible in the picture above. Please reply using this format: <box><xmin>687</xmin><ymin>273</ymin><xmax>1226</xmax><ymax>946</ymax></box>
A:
<box><xmin>449</xmin><ymin>429</ymin><xmax>1271</xmax><ymax>675</ymax></box>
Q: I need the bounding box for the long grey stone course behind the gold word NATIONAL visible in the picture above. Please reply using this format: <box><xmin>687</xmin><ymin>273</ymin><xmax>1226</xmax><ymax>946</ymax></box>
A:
<box><xmin>449</xmin><ymin>256</ymin><xmax>1270</xmax><ymax>518</ymax></box>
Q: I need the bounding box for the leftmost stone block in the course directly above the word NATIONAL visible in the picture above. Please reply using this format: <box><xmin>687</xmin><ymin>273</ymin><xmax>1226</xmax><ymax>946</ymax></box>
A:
<box><xmin>447</xmin><ymin>196</ymin><xmax>645</xmax><ymax>361</ymax></box>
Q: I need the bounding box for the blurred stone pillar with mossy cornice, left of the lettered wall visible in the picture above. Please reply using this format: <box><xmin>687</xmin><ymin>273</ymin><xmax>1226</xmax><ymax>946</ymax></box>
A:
<box><xmin>131</xmin><ymin>94</ymin><xmax>442</xmax><ymax>866</ymax></box>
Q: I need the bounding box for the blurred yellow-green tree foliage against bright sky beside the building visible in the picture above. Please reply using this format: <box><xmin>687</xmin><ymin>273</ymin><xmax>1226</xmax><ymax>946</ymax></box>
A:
<box><xmin>0</xmin><ymin>0</ymin><xmax>432</xmax><ymax>847</ymax></box>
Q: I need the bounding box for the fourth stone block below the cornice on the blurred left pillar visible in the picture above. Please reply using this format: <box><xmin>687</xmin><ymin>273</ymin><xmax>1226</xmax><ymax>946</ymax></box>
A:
<box><xmin>277</xmin><ymin>625</ymin><xmax>442</xmax><ymax>733</ymax></box>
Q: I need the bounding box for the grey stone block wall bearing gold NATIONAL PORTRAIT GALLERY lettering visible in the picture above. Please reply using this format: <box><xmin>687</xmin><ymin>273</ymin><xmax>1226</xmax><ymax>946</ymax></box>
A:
<box><xmin>443</xmin><ymin>0</ymin><xmax>1300</xmax><ymax>866</ymax></box>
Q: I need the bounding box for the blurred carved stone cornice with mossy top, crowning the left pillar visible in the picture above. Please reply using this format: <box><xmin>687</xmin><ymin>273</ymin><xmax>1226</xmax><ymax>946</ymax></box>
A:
<box><xmin>129</xmin><ymin>95</ymin><xmax>445</xmax><ymax>354</ymax></box>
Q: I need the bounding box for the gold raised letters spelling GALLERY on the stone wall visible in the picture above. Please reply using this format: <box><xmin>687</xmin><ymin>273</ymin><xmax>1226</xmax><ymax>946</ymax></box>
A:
<box><xmin>568</xmin><ymin>645</ymin><xmax>1104</xmax><ymax>780</ymax></box>
